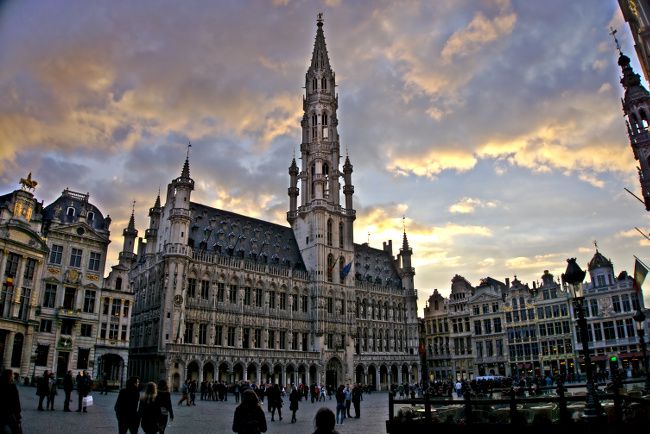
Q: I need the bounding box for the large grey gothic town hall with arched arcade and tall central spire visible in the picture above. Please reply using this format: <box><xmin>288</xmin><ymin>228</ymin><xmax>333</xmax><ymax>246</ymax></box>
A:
<box><xmin>130</xmin><ymin>16</ymin><xmax>419</xmax><ymax>387</ymax></box>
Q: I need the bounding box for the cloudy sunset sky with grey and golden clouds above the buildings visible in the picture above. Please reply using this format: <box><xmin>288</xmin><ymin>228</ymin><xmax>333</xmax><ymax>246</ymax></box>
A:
<box><xmin>0</xmin><ymin>0</ymin><xmax>650</xmax><ymax>308</ymax></box>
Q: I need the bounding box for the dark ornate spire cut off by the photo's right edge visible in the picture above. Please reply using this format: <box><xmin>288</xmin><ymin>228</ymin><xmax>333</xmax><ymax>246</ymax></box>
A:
<box><xmin>618</xmin><ymin>53</ymin><xmax>650</xmax><ymax>211</ymax></box>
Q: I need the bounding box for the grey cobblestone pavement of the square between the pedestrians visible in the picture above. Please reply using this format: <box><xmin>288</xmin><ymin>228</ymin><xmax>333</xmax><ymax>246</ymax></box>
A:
<box><xmin>18</xmin><ymin>386</ymin><xmax>388</xmax><ymax>434</ymax></box>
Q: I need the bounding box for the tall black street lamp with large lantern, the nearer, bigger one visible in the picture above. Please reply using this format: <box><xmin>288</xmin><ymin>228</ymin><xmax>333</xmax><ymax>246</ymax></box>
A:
<box><xmin>562</xmin><ymin>258</ymin><xmax>602</xmax><ymax>421</ymax></box>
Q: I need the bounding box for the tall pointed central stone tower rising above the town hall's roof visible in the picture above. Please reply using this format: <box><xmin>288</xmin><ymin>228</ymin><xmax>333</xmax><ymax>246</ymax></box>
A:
<box><xmin>287</xmin><ymin>15</ymin><xmax>356</xmax><ymax>284</ymax></box>
